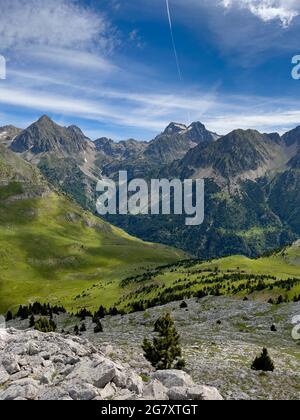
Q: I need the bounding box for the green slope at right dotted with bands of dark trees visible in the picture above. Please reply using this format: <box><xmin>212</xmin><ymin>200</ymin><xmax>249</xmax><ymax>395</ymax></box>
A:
<box><xmin>114</xmin><ymin>241</ymin><xmax>300</xmax><ymax>310</ymax></box>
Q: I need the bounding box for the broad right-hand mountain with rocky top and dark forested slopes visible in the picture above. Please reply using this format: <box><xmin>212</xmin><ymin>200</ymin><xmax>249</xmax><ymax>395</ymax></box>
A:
<box><xmin>108</xmin><ymin>124</ymin><xmax>300</xmax><ymax>258</ymax></box>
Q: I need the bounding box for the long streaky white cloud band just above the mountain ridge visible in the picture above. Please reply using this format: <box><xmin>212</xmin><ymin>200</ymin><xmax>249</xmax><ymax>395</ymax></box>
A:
<box><xmin>0</xmin><ymin>80</ymin><xmax>300</xmax><ymax>139</ymax></box>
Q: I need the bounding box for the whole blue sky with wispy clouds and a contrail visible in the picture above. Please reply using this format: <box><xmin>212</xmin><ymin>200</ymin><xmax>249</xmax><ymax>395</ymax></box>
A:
<box><xmin>0</xmin><ymin>0</ymin><xmax>300</xmax><ymax>140</ymax></box>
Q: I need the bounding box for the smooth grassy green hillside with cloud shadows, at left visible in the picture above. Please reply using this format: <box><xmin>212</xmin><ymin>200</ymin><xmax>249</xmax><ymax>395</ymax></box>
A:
<box><xmin>0</xmin><ymin>146</ymin><xmax>184</xmax><ymax>312</ymax></box>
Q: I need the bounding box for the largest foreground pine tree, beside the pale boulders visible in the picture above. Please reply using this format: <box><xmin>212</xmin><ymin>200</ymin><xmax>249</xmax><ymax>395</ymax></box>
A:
<box><xmin>142</xmin><ymin>314</ymin><xmax>185</xmax><ymax>369</ymax></box>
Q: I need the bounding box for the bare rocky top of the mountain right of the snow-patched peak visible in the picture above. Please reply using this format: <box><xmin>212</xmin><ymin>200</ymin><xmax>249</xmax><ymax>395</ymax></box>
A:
<box><xmin>166</xmin><ymin>130</ymin><xmax>289</xmax><ymax>185</ymax></box>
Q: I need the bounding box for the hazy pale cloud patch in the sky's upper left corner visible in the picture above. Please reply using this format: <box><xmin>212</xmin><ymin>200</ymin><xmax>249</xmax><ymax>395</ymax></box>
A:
<box><xmin>0</xmin><ymin>0</ymin><xmax>110</xmax><ymax>51</ymax></box>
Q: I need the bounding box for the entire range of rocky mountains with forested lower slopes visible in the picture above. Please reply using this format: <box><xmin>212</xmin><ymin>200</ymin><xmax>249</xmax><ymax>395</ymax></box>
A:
<box><xmin>0</xmin><ymin>116</ymin><xmax>300</xmax><ymax>258</ymax></box>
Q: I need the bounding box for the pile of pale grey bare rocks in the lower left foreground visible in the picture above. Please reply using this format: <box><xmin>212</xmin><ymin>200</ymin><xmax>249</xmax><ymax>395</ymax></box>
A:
<box><xmin>0</xmin><ymin>329</ymin><xmax>222</xmax><ymax>400</ymax></box>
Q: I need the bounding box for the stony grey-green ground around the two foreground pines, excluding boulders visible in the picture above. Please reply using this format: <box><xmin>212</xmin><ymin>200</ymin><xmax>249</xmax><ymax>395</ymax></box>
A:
<box><xmin>7</xmin><ymin>297</ymin><xmax>300</xmax><ymax>400</ymax></box>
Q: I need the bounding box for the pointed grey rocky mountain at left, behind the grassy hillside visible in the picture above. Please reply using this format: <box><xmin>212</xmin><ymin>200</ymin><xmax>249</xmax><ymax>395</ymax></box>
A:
<box><xmin>10</xmin><ymin>115</ymin><xmax>100</xmax><ymax>210</ymax></box>
